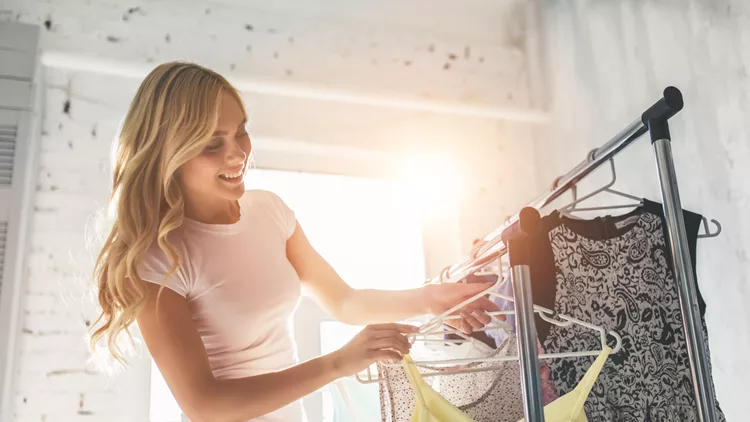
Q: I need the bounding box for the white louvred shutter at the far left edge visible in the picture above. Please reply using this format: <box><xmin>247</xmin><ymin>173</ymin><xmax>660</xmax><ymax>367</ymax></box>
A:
<box><xmin>0</xmin><ymin>22</ymin><xmax>42</xmax><ymax>421</ymax></box>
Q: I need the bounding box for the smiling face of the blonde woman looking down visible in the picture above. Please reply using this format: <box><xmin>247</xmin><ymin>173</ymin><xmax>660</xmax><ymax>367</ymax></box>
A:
<box><xmin>179</xmin><ymin>93</ymin><xmax>251</xmax><ymax>203</ymax></box>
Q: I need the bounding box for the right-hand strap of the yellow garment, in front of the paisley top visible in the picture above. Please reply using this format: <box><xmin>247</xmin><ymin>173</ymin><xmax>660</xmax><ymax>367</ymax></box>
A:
<box><xmin>519</xmin><ymin>347</ymin><xmax>612</xmax><ymax>422</ymax></box>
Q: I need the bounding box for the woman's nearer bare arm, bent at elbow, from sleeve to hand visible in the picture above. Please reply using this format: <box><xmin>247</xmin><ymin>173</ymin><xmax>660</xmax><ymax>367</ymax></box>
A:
<box><xmin>138</xmin><ymin>283</ymin><xmax>414</xmax><ymax>422</ymax></box>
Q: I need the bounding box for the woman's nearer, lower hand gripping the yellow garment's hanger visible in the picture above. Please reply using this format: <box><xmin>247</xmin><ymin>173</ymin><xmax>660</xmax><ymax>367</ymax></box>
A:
<box><xmin>329</xmin><ymin>324</ymin><xmax>418</xmax><ymax>377</ymax></box>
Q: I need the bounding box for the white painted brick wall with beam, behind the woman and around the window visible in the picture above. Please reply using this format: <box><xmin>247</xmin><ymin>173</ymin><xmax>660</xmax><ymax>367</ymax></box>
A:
<box><xmin>0</xmin><ymin>0</ymin><xmax>545</xmax><ymax>421</ymax></box>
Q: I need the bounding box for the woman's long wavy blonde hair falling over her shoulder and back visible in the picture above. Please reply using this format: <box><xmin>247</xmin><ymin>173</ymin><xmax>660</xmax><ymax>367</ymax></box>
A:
<box><xmin>89</xmin><ymin>62</ymin><xmax>244</xmax><ymax>363</ymax></box>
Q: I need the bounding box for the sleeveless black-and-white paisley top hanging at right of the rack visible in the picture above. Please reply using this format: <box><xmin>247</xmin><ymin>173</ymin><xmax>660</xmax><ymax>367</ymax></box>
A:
<box><xmin>511</xmin><ymin>200</ymin><xmax>725</xmax><ymax>422</ymax></box>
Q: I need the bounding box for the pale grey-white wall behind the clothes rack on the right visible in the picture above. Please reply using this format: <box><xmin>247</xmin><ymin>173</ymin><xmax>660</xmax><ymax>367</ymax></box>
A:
<box><xmin>537</xmin><ymin>0</ymin><xmax>750</xmax><ymax>421</ymax></box>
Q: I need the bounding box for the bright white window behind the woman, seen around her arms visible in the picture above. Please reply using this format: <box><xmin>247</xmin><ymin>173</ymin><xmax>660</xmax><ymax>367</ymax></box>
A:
<box><xmin>151</xmin><ymin>169</ymin><xmax>425</xmax><ymax>422</ymax></box>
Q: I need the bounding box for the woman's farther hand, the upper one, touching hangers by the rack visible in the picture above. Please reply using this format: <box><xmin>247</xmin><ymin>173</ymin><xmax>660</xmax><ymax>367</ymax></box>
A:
<box><xmin>424</xmin><ymin>283</ymin><xmax>504</xmax><ymax>334</ymax></box>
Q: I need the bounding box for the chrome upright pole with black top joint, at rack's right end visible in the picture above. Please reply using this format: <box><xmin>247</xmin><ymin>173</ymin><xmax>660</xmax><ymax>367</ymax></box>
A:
<box><xmin>643</xmin><ymin>87</ymin><xmax>717</xmax><ymax>422</ymax></box>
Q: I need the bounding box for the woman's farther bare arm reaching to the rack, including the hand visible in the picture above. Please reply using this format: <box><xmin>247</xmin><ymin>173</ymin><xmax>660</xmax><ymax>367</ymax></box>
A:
<box><xmin>286</xmin><ymin>219</ymin><xmax>497</xmax><ymax>332</ymax></box>
